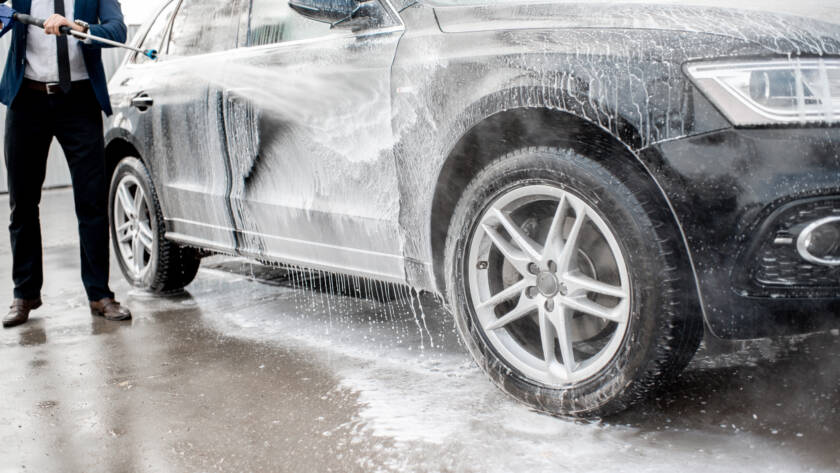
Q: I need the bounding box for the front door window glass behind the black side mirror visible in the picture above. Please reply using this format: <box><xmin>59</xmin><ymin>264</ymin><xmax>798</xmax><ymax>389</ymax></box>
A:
<box><xmin>248</xmin><ymin>0</ymin><xmax>331</xmax><ymax>46</ymax></box>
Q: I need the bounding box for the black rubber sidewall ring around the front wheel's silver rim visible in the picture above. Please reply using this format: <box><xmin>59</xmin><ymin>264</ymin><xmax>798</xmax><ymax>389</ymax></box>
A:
<box><xmin>446</xmin><ymin>149</ymin><xmax>676</xmax><ymax>416</ymax></box>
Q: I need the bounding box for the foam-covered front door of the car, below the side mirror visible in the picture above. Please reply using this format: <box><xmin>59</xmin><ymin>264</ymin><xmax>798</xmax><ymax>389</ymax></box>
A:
<box><xmin>217</xmin><ymin>0</ymin><xmax>405</xmax><ymax>281</ymax></box>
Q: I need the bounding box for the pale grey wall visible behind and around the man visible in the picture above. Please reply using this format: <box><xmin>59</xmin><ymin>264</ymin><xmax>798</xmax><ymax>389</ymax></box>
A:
<box><xmin>0</xmin><ymin>25</ymin><xmax>139</xmax><ymax>193</ymax></box>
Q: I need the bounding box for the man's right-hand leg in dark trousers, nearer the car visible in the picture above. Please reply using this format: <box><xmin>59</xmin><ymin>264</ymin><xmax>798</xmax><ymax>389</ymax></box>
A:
<box><xmin>55</xmin><ymin>84</ymin><xmax>114</xmax><ymax>301</ymax></box>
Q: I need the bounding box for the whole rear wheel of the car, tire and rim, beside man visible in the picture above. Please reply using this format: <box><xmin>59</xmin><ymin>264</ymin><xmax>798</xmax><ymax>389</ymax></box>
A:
<box><xmin>108</xmin><ymin>157</ymin><xmax>201</xmax><ymax>294</ymax></box>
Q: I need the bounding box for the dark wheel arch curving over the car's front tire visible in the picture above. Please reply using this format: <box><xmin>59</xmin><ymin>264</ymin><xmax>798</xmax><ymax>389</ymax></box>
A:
<box><xmin>429</xmin><ymin>107</ymin><xmax>702</xmax><ymax>318</ymax></box>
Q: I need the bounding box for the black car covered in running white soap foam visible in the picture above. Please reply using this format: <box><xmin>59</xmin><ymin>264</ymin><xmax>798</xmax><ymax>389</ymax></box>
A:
<box><xmin>107</xmin><ymin>0</ymin><xmax>840</xmax><ymax>416</ymax></box>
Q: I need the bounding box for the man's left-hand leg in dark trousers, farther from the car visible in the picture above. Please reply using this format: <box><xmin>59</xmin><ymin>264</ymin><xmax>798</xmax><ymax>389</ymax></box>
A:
<box><xmin>5</xmin><ymin>90</ymin><xmax>52</xmax><ymax>299</ymax></box>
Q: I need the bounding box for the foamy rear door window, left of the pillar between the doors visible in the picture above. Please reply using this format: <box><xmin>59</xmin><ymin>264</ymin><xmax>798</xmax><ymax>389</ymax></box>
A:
<box><xmin>168</xmin><ymin>0</ymin><xmax>241</xmax><ymax>56</ymax></box>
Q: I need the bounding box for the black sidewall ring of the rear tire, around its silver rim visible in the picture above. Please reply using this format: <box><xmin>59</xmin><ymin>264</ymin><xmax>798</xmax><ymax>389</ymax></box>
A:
<box><xmin>108</xmin><ymin>157</ymin><xmax>160</xmax><ymax>290</ymax></box>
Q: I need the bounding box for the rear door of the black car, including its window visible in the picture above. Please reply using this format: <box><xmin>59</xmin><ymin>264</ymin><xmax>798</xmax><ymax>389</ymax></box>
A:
<box><xmin>140</xmin><ymin>0</ymin><xmax>247</xmax><ymax>250</ymax></box>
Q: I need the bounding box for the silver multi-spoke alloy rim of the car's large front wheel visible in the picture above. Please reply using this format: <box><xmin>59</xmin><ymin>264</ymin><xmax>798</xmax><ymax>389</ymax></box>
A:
<box><xmin>467</xmin><ymin>184</ymin><xmax>631</xmax><ymax>387</ymax></box>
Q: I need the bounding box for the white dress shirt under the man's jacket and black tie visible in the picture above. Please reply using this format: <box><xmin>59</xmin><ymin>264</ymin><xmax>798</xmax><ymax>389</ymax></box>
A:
<box><xmin>24</xmin><ymin>0</ymin><xmax>88</xmax><ymax>82</ymax></box>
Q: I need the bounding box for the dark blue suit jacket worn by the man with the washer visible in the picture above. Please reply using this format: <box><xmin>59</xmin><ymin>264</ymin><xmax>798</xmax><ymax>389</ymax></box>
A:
<box><xmin>0</xmin><ymin>0</ymin><xmax>127</xmax><ymax>115</ymax></box>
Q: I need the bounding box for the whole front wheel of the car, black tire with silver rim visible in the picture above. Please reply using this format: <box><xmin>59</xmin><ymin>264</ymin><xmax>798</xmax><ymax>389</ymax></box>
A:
<box><xmin>445</xmin><ymin>148</ymin><xmax>703</xmax><ymax>417</ymax></box>
